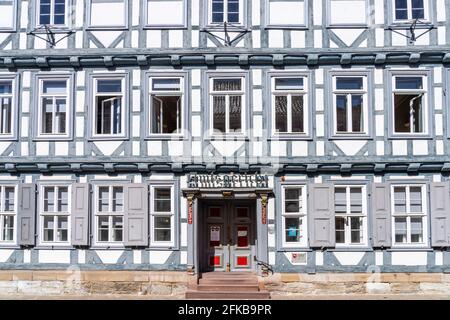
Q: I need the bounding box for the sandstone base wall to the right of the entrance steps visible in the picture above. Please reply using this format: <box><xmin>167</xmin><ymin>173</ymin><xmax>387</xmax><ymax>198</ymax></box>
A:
<box><xmin>260</xmin><ymin>273</ymin><xmax>450</xmax><ymax>296</ymax></box>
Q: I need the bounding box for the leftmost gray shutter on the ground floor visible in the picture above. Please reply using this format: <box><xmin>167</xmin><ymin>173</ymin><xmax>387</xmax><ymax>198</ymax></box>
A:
<box><xmin>17</xmin><ymin>183</ymin><xmax>36</xmax><ymax>246</ymax></box>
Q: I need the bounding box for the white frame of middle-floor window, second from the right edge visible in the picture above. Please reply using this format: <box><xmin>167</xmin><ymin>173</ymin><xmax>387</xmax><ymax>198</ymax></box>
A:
<box><xmin>331</xmin><ymin>72</ymin><xmax>370</xmax><ymax>137</ymax></box>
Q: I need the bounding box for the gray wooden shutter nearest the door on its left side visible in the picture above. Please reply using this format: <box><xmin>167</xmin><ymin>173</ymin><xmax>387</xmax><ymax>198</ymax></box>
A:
<box><xmin>124</xmin><ymin>183</ymin><xmax>149</xmax><ymax>246</ymax></box>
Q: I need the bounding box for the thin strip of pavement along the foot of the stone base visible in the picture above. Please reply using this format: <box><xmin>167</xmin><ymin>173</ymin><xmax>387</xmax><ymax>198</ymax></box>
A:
<box><xmin>0</xmin><ymin>294</ymin><xmax>450</xmax><ymax>301</ymax></box>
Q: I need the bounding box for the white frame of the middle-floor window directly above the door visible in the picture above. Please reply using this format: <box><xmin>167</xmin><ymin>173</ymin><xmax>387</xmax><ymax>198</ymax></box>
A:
<box><xmin>208</xmin><ymin>74</ymin><xmax>248</xmax><ymax>137</ymax></box>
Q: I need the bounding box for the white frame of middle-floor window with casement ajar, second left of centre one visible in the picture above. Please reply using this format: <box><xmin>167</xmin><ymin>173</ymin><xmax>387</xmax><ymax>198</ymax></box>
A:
<box><xmin>91</xmin><ymin>74</ymin><xmax>128</xmax><ymax>140</ymax></box>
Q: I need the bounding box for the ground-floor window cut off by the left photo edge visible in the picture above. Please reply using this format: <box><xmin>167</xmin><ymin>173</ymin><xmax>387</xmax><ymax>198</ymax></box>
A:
<box><xmin>0</xmin><ymin>185</ymin><xmax>17</xmax><ymax>244</ymax></box>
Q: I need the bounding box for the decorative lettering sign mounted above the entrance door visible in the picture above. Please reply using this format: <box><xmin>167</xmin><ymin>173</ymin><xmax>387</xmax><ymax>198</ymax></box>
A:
<box><xmin>188</xmin><ymin>173</ymin><xmax>269</xmax><ymax>189</ymax></box>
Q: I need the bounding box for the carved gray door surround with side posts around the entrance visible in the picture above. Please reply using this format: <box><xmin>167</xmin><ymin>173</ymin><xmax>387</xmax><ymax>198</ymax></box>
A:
<box><xmin>181</xmin><ymin>188</ymin><xmax>274</xmax><ymax>277</ymax></box>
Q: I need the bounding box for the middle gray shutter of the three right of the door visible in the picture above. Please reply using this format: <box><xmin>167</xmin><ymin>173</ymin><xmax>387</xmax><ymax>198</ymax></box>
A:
<box><xmin>372</xmin><ymin>183</ymin><xmax>392</xmax><ymax>247</ymax></box>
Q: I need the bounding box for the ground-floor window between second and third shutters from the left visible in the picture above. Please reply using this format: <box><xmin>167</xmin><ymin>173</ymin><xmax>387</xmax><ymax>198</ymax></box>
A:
<box><xmin>95</xmin><ymin>186</ymin><xmax>124</xmax><ymax>243</ymax></box>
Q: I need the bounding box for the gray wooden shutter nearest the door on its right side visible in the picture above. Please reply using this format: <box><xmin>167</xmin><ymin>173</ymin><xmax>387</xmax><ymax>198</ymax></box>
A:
<box><xmin>308</xmin><ymin>184</ymin><xmax>336</xmax><ymax>247</ymax></box>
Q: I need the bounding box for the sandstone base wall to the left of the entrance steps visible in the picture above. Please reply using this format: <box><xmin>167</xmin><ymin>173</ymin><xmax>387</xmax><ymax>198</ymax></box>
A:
<box><xmin>0</xmin><ymin>270</ymin><xmax>195</xmax><ymax>298</ymax></box>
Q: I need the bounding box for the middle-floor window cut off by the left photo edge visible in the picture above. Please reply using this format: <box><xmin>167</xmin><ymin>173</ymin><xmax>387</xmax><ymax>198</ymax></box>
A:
<box><xmin>0</xmin><ymin>78</ymin><xmax>14</xmax><ymax>137</ymax></box>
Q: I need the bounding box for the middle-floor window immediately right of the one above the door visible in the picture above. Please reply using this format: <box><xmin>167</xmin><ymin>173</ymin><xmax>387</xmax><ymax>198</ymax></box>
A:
<box><xmin>272</xmin><ymin>76</ymin><xmax>308</xmax><ymax>134</ymax></box>
